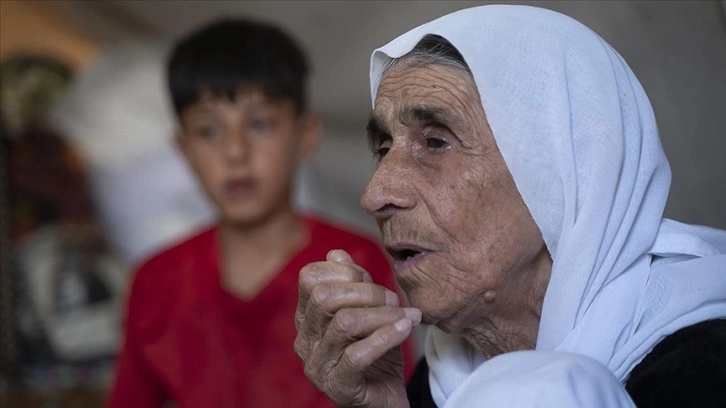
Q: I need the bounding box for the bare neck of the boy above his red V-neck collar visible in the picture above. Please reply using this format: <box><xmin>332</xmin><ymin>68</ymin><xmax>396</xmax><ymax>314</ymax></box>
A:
<box><xmin>219</xmin><ymin>210</ymin><xmax>308</xmax><ymax>299</ymax></box>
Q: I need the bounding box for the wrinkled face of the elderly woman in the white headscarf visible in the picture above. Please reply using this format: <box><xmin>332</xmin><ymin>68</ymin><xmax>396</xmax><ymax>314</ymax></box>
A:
<box><xmin>361</xmin><ymin>65</ymin><xmax>544</xmax><ymax>332</ymax></box>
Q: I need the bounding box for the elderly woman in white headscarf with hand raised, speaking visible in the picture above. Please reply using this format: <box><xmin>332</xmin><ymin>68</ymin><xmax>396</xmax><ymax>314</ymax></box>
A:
<box><xmin>295</xmin><ymin>6</ymin><xmax>726</xmax><ymax>408</ymax></box>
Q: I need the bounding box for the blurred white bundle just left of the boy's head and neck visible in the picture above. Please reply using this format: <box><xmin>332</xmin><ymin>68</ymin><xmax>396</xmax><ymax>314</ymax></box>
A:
<box><xmin>50</xmin><ymin>42</ymin><xmax>215</xmax><ymax>266</ymax></box>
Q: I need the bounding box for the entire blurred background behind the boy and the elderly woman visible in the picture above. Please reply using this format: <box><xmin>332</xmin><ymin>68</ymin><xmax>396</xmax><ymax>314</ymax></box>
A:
<box><xmin>0</xmin><ymin>0</ymin><xmax>726</xmax><ymax>408</ymax></box>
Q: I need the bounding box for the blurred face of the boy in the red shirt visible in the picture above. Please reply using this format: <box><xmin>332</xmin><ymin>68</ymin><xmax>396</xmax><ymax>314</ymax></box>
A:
<box><xmin>178</xmin><ymin>91</ymin><xmax>319</xmax><ymax>225</ymax></box>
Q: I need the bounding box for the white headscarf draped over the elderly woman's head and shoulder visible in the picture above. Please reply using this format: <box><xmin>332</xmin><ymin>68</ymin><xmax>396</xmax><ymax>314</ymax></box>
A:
<box><xmin>371</xmin><ymin>5</ymin><xmax>726</xmax><ymax>406</ymax></box>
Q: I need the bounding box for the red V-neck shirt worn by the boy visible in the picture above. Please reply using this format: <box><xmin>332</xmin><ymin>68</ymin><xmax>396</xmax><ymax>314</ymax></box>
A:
<box><xmin>110</xmin><ymin>217</ymin><xmax>413</xmax><ymax>408</ymax></box>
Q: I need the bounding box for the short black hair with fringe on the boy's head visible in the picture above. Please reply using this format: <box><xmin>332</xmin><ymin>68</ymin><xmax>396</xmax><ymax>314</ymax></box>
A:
<box><xmin>167</xmin><ymin>19</ymin><xmax>308</xmax><ymax>117</ymax></box>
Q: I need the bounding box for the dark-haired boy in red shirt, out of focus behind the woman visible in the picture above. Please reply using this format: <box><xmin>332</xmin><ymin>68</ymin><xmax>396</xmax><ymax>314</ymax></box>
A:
<box><xmin>110</xmin><ymin>20</ymin><xmax>411</xmax><ymax>408</ymax></box>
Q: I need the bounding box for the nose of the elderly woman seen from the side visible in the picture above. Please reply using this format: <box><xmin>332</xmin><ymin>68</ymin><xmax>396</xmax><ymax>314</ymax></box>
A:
<box><xmin>360</xmin><ymin>149</ymin><xmax>416</xmax><ymax>218</ymax></box>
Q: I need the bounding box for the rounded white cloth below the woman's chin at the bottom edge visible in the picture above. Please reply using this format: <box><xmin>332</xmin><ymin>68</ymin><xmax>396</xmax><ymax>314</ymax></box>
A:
<box><xmin>426</xmin><ymin>330</ymin><xmax>633</xmax><ymax>408</ymax></box>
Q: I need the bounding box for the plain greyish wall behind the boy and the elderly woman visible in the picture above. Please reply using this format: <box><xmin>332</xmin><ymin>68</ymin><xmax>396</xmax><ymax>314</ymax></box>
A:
<box><xmin>58</xmin><ymin>1</ymin><xmax>726</xmax><ymax>236</ymax></box>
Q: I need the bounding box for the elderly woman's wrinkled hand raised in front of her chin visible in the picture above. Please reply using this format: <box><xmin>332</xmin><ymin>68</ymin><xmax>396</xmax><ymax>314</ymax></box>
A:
<box><xmin>295</xmin><ymin>250</ymin><xmax>421</xmax><ymax>408</ymax></box>
